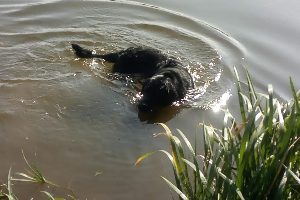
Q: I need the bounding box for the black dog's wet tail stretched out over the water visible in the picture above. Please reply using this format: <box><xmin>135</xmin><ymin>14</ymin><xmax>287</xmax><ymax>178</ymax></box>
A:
<box><xmin>72</xmin><ymin>44</ymin><xmax>119</xmax><ymax>63</ymax></box>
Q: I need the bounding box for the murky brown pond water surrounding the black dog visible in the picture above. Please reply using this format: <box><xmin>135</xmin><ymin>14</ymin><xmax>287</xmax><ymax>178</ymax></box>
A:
<box><xmin>0</xmin><ymin>0</ymin><xmax>300</xmax><ymax>200</ymax></box>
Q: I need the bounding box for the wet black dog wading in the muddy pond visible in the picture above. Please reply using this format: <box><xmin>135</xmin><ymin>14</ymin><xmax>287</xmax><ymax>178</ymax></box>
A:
<box><xmin>72</xmin><ymin>44</ymin><xmax>194</xmax><ymax>112</ymax></box>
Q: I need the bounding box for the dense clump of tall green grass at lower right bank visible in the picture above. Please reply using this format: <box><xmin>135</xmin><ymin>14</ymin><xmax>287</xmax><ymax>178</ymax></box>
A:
<box><xmin>136</xmin><ymin>69</ymin><xmax>300</xmax><ymax>200</ymax></box>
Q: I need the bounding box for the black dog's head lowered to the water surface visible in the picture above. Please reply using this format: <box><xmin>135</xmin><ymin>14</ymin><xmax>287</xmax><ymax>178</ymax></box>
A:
<box><xmin>138</xmin><ymin>74</ymin><xmax>178</xmax><ymax>112</ymax></box>
